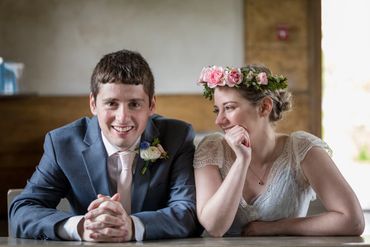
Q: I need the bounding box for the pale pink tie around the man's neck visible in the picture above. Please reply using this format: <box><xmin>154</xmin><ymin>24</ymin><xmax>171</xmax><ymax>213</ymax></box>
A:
<box><xmin>117</xmin><ymin>152</ymin><xmax>135</xmax><ymax>214</ymax></box>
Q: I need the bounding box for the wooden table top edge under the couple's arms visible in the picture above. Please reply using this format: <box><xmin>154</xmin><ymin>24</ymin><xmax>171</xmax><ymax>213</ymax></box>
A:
<box><xmin>0</xmin><ymin>236</ymin><xmax>370</xmax><ymax>247</ymax></box>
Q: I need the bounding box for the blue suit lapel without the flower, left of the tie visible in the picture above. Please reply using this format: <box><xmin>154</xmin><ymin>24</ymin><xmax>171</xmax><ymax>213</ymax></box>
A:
<box><xmin>82</xmin><ymin>117</ymin><xmax>111</xmax><ymax>196</ymax></box>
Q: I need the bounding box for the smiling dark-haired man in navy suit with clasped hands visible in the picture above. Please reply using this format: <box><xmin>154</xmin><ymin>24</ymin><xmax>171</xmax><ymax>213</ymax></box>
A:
<box><xmin>9</xmin><ymin>50</ymin><xmax>200</xmax><ymax>242</ymax></box>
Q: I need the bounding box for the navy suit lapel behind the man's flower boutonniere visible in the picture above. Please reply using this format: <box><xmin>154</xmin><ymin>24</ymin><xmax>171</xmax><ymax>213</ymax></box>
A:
<box><xmin>131</xmin><ymin>118</ymin><xmax>159</xmax><ymax>213</ymax></box>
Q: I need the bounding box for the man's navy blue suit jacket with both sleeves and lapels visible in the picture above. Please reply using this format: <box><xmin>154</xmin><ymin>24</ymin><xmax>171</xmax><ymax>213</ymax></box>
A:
<box><xmin>9</xmin><ymin>115</ymin><xmax>200</xmax><ymax>240</ymax></box>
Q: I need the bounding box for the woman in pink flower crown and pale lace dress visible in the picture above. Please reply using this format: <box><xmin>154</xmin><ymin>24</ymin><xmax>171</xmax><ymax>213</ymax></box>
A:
<box><xmin>194</xmin><ymin>65</ymin><xmax>364</xmax><ymax>237</ymax></box>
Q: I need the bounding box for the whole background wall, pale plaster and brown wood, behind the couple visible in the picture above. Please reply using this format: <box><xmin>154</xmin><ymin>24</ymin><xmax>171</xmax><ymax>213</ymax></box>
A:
<box><xmin>0</xmin><ymin>0</ymin><xmax>321</xmax><ymax>236</ymax></box>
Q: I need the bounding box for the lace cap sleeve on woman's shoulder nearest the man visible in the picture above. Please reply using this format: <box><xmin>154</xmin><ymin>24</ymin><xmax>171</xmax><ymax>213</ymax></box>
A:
<box><xmin>193</xmin><ymin>133</ymin><xmax>224</xmax><ymax>168</ymax></box>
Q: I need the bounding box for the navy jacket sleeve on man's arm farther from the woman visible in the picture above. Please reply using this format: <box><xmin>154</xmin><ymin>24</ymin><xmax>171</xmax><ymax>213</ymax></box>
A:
<box><xmin>8</xmin><ymin>133</ymin><xmax>72</xmax><ymax>240</ymax></box>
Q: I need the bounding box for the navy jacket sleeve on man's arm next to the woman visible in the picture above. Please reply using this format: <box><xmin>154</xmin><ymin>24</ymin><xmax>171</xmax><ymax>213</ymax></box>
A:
<box><xmin>134</xmin><ymin>125</ymin><xmax>202</xmax><ymax>240</ymax></box>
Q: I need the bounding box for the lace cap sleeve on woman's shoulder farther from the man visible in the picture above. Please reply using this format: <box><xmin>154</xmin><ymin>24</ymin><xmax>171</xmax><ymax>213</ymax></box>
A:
<box><xmin>292</xmin><ymin>131</ymin><xmax>333</xmax><ymax>163</ymax></box>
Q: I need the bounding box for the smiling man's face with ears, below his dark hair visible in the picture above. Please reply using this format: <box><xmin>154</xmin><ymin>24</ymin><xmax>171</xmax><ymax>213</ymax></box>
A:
<box><xmin>90</xmin><ymin>83</ymin><xmax>155</xmax><ymax>151</ymax></box>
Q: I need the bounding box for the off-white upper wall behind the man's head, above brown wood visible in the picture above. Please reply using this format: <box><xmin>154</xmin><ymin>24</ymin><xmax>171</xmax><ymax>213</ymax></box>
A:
<box><xmin>0</xmin><ymin>0</ymin><xmax>244</xmax><ymax>95</ymax></box>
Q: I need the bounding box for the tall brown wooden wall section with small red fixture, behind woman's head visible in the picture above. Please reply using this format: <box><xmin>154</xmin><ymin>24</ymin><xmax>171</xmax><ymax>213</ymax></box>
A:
<box><xmin>244</xmin><ymin>0</ymin><xmax>321</xmax><ymax>137</ymax></box>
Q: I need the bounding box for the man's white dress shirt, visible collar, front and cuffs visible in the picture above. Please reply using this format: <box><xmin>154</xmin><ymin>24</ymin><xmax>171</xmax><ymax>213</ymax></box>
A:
<box><xmin>57</xmin><ymin>132</ymin><xmax>145</xmax><ymax>241</ymax></box>
